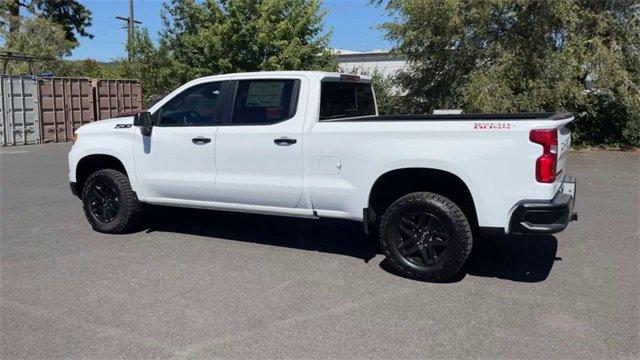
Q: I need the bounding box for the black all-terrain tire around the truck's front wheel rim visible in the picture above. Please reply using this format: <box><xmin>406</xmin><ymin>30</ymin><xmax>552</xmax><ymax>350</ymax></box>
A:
<box><xmin>82</xmin><ymin>169</ymin><xmax>141</xmax><ymax>234</ymax></box>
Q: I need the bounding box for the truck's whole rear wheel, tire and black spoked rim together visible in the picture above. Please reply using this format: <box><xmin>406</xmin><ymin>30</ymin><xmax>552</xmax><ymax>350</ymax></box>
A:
<box><xmin>380</xmin><ymin>192</ymin><xmax>473</xmax><ymax>281</ymax></box>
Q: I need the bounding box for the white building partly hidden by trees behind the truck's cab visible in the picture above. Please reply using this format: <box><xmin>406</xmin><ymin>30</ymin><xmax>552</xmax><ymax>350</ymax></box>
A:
<box><xmin>334</xmin><ymin>49</ymin><xmax>407</xmax><ymax>76</ymax></box>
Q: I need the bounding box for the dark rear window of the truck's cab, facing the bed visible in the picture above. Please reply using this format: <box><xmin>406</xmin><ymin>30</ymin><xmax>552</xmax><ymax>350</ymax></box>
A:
<box><xmin>320</xmin><ymin>79</ymin><xmax>376</xmax><ymax>121</ymax></box>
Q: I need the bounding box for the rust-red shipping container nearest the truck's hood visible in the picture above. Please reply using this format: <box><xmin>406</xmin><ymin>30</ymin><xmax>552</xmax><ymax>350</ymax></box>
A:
<box><xmin>94</xmin><ymin>80</ymin><xmax>142</xmax><ymax>120</ymax></box>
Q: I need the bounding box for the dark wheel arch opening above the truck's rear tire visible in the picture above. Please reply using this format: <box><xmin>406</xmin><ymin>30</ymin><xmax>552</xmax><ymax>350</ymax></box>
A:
<box><xmin>365</xmin><ymin>167</ymin><xmax>478</xmax><ymax>227</ymax></box>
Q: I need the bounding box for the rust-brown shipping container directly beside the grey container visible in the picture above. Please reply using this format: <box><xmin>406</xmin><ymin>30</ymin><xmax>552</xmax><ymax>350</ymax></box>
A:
<box><xmin>39</xmin><ymin>78</ymin><xmax>95</xmax><ymax>143</ymax></box>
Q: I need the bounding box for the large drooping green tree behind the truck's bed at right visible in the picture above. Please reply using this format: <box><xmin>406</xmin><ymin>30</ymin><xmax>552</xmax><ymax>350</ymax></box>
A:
<box><xmin>374</xmin><ymin>0</ymin><xmax>640</xmax><ymax>146</ymax></box>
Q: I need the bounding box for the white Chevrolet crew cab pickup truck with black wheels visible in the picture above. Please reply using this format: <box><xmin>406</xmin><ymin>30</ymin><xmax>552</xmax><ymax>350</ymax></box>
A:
<box><xmin>69</xmin><ymin>71</ymin><xmax>577</xmax><ymax>280</ymax></box>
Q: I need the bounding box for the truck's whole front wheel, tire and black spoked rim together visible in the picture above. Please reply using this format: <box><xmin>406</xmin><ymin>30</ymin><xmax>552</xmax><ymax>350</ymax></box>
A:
<box><xmin>82</xmin><ymin>169</ymin><xmax>139</xmax><ymax>234</ymax></box>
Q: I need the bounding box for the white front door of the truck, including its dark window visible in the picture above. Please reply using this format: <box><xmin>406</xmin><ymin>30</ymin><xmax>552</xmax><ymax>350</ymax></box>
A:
<box><xmin>133</xmin><ymin>81</ymin><xmax>228</xmax><ymax>203</ymax></box>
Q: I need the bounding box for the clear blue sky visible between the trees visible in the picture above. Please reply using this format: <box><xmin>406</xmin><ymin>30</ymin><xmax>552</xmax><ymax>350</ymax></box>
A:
<box><xmin>70</xmin><ymin>0</ymin><xmax>391</xmax><ymax>61</ymax></box>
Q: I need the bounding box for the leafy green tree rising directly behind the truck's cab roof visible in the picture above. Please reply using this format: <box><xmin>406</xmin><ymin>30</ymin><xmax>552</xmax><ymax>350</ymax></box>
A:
<box><xmin>160</xmin><ymin>0</ymin><xmax>335</xmax><ymax>81</ymax></box>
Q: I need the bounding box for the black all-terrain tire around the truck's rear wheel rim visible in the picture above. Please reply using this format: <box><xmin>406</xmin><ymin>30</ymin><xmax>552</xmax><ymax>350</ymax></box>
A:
<box><xmin>380</xmin><ymin>192</ymin><xmax>473</xmax><ymax>281</ymax></box>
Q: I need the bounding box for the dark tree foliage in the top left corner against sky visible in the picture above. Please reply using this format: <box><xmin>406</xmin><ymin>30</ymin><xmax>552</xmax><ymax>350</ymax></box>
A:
<box><xmin>0</xmin><ymin>0</ymin><xmax>93</xmax><ymax>47</ymax></box>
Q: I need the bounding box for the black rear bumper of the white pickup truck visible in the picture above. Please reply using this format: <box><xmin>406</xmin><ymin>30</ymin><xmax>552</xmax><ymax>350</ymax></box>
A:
<box><xmin>508</xmin><ymin>175</ymin><xmax>578</xmax><ymax>234</ymax></box>
